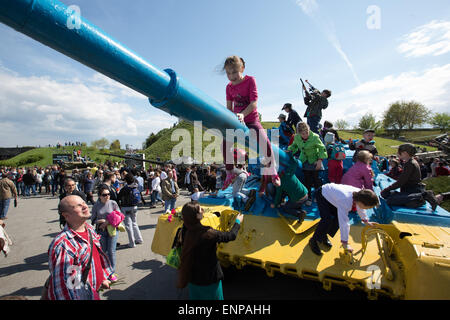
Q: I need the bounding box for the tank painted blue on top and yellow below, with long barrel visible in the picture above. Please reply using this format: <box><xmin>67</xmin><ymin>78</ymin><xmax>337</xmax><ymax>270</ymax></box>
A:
<box><xmin>0</xmin><ymin>0</ymin><xmax>450</xmax><ymax>299</ymax></box>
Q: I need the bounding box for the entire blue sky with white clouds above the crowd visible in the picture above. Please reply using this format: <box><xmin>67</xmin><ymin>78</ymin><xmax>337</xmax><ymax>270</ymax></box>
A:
<box><xmin>0</xmin><ymin>0</ymin><xmax>450</xmax><ymax>147</ymax></box>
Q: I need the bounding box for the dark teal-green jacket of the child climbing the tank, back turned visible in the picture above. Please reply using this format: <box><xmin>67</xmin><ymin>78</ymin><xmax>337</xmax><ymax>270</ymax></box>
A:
<box><xmin>274</xmin><ymin>157</ymin><xmax>308</xmax><ymax>206</ymax></box>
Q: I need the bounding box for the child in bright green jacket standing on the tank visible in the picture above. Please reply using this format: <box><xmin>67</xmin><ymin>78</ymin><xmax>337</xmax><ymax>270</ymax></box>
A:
<box><xmin>287</xmin><ymin>122</ymin><xmax>328</xmax><ymax>206</ymax></box>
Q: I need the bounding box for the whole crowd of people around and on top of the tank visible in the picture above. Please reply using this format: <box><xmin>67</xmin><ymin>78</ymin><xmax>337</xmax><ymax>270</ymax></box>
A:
<box><xmin>0</xmin><ymin>56</ymin><xmax>448</xmax><ymax>299</ymax></box>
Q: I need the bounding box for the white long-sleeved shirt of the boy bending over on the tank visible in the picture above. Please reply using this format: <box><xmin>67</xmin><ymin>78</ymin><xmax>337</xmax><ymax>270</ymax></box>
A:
<box><xmin>322</xmin><ymin>183</ymin><xmax>369</xmax><ymax>241</ymax></box>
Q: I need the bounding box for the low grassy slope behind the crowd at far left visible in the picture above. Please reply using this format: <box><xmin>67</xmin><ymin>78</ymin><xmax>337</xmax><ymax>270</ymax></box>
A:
<box><xmin>0</xmin><ymin>147</ymin><xmax>125</xmax><ymax>167</ymax></box>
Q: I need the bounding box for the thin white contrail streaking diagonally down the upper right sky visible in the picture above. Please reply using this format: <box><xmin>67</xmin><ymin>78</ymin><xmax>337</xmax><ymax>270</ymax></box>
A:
<box><xmin>297</xmin><ymin>0</ymin><xmax>361</xmax><ymax>85</ymax></box>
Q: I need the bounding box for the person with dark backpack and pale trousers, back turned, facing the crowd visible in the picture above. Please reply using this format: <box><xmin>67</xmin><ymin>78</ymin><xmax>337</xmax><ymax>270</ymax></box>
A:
<box><xmin>118</xmin><ymin>173</ymin><xmax>144</xmax><ymax>248</ymax></box>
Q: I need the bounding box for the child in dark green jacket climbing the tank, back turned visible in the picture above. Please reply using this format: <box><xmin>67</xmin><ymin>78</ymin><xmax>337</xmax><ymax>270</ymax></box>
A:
<box><xmin>271</xmin><ymin>156</ymin><xmax>308</xmax><ymax>220</ymax></box>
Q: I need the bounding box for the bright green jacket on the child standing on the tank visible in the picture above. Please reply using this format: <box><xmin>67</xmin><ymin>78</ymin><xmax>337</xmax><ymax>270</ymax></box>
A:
<box><xmin>288</xmin><ymin>130</ymin><xmax>328</xmax><ymax>164</ymax></box>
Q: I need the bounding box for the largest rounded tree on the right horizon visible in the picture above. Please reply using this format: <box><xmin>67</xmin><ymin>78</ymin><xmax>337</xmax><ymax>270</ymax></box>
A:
<box><xmin>383</xmin><ymin>101</ymin><xmax>430</xmax><ymax>137</ymax></box>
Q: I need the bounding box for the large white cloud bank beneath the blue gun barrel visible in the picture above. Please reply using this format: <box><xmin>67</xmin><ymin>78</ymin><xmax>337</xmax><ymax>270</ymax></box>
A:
<box><xmin>0</xmin><ymin>67</ymin><xmax>177</xmax><ymax>147</ymax></box>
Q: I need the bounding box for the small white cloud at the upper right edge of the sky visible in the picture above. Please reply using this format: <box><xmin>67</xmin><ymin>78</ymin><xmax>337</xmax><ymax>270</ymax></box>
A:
<box><xmin>397</xmin><ymin>20</ymin><xmax>450</xmax><ymax>58</ymax></box>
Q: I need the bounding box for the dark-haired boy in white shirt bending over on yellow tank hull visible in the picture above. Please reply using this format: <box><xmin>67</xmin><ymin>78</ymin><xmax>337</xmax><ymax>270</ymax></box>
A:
<box><xmin>309</xmin><ymin>183</ymin><xmax>379</xmax><ymax>255</ymax></box>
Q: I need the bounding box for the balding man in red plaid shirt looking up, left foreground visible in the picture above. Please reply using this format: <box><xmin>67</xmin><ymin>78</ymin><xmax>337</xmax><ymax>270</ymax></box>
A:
<box><xmin>47</xmin><ymin>195</ymin><xmax>113</xmax><ymax>300</ymax></box>
